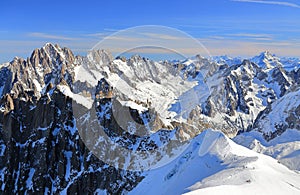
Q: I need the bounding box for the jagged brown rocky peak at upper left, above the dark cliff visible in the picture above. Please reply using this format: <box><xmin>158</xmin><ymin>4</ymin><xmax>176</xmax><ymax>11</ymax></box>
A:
<box><xmin>0</xmin><ymin>43</ymin><xmax>76</xmax><ymax>100</ymax></box>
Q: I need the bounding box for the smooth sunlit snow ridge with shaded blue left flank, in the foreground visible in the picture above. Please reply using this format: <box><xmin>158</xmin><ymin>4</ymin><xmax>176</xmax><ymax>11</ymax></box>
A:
<box><xmin>130</xmin><ymin>130</ymin><xmax>300</xmax><ymax>194</ymax></box>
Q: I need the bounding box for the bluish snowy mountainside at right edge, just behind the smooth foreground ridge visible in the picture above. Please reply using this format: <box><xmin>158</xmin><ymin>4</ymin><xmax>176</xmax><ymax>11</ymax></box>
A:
<box><xmin>234</xmin><ymin>89</ymin><xmax>300</xmax><ymax>171</ymax></box>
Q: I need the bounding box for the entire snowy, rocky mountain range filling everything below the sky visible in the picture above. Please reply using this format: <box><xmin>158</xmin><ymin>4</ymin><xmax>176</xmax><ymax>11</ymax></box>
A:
<box><xmin>0</xmin><ymin>43</ymin><xmax>300</xmax><ymax>194</ymax></box>
